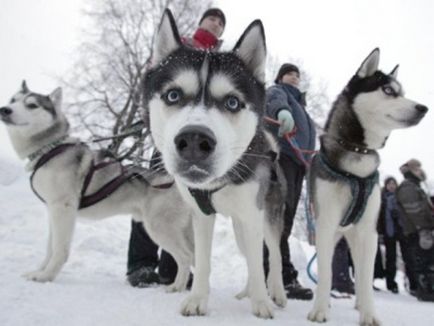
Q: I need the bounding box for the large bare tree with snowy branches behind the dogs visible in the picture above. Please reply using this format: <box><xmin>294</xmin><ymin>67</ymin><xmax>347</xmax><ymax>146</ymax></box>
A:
<box><xmin>62</xmin><ymin>0</ymin><xmax>210</xmax><ymax>163</ymax></box>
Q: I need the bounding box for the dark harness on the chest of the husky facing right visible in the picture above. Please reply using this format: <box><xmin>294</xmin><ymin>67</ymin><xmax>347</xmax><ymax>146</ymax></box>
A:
<box><xmin>315</xmin><ymin>151</ymin><xmax>379</xmax><ymax>227</ymax></box>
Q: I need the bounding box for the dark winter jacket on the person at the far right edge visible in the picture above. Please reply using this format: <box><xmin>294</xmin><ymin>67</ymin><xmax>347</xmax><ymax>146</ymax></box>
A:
<box><xmin>396</xmin><ymin>177</ymin><xmax>434</xmax><ymax>235</ymax></box>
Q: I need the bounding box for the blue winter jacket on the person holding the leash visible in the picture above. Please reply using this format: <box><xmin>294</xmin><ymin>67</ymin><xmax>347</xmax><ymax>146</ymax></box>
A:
<box><xmin>266</xmin><ymin>83</ymin><xmax>315</xmax><ymax>165</ymax></box>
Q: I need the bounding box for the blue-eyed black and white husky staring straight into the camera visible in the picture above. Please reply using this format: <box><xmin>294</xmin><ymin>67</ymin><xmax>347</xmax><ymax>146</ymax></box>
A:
<box><xmin>144</xmin><ymin>11</ymin><xmax>286</xmax><ymax>318</ymax></box>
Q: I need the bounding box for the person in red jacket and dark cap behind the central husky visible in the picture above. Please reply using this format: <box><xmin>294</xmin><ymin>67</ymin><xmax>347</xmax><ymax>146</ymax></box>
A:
<box><xmin>127</xmin><ymin>8</ymin><xmax>226</xmax><ymax>287</ymax></box>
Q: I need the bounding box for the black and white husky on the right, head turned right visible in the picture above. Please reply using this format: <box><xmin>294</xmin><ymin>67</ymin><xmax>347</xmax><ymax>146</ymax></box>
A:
<box><xmin>308</xmin><ymin>49</ymin><xmax>428</xmax><ymax>325</ymax></box>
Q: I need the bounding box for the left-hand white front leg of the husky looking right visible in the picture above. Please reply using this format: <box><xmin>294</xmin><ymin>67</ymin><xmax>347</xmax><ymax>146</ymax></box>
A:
<box><xmin>307</xmin><ymin>219</ymin><xmax>336</xmax><ymax>323</ymax></box>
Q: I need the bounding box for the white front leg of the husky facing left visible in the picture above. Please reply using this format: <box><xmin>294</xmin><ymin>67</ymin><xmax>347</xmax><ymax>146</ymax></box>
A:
<box><xmin>25</xmin><ymin>203</ymin><xmax>77</xmax><ymax>282</ymax></box>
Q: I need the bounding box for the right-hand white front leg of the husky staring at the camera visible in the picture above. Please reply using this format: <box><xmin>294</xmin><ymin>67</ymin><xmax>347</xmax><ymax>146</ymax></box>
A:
<box><xmin>239</xmin><ymin>211</ymin><xmax>274</xmax><ymax>318</ymax></box>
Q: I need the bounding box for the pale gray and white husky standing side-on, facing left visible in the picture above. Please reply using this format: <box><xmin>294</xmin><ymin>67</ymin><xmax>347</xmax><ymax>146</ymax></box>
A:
<box><xmin>0</xmin><ymin>82</ymin><xmax>194</xmax><ymax>291</ymax></box>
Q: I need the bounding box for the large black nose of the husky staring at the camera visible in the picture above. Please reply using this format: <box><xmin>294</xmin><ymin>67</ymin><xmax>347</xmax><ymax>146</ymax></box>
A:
<box><xmin>175</xmin><ymin>126</ymin><xmax>217</xmax><ymax>162</ymax></box>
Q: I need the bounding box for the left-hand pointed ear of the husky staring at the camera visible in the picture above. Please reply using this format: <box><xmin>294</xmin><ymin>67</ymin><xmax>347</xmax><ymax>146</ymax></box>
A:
<box><xmin>151</xmin><ymin>9</ymin><xmax>182</xmax><ymax>67</ymax></box>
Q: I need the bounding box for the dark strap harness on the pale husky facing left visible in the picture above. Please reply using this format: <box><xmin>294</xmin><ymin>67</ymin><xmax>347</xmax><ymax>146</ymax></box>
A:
<box><xmin>30</xmin><ymin>143</ymin><xmax>174</xmax><ymax>209</ymax></box>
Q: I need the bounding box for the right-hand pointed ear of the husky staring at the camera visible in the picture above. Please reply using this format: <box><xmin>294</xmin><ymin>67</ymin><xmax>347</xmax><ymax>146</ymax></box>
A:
<box><xmin>233</xmin><ymin>19</ymin><xmax>267</xmax><ymax>82</ymax></box>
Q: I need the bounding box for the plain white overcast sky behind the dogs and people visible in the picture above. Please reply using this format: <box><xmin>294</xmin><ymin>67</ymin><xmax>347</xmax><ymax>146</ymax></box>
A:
<box><xmin>0</xmin><ymin>0</ymin><xmax>434</xmax><ymax>190</ymax></box>
